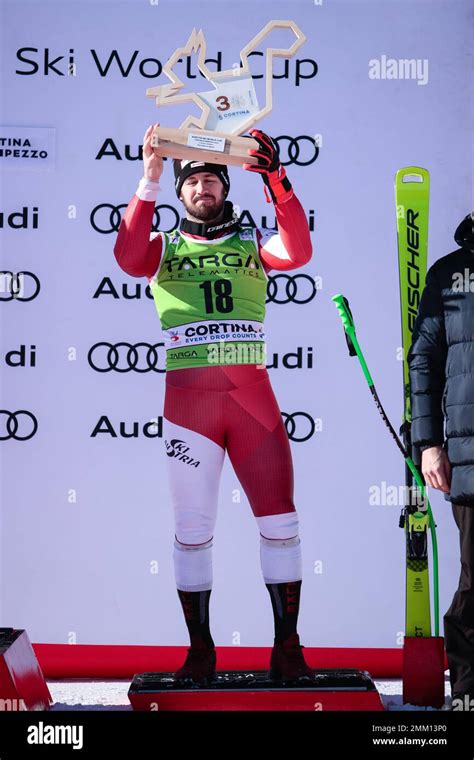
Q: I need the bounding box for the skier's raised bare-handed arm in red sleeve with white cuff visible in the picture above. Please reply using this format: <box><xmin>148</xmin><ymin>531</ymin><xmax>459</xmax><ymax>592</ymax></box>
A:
<box><xmin>114</xmin><ymin>125</ymin><xmax>163</xmax><ymax>277</ymax></box>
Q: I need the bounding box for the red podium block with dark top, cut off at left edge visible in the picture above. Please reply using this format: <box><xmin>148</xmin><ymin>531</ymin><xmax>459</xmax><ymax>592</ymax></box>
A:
<box><xmin>0</xmin><ymin>628</ymin><xmax>52</xmax><ymax>712</ymax></box>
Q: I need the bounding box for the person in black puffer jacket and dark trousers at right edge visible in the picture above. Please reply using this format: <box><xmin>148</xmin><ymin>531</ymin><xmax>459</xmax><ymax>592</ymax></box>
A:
<box><xmin>408</xmin><ymin>212</ymin><xmax>474</xmax><ymax>703</ymax></box>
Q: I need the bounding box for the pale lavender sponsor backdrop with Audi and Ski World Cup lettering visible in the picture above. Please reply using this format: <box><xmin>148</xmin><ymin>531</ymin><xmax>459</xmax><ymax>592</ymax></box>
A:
<box><xmin>0</xmin><ymin>0</ymin><xmax>473</xmax><ymax>647</ymax></box>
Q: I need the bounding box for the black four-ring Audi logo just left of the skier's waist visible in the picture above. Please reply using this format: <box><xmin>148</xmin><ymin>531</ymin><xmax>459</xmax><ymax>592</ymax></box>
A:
<box><xmin>87</xmin><ymin>341</ymin><xmax>166</xmax><ymax>373</ymax></box>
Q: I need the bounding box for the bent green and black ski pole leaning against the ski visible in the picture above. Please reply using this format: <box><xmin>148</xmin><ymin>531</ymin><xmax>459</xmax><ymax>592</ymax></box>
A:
<box><xmin>332</xmin><ymin>294</ymin><xmax>439</xmax><ymax>636</ymax></box>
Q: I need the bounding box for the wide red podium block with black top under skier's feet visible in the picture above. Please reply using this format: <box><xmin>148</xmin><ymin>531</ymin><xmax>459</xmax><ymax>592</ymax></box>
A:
<box><xmin>128</xmin><ymin>668</ymin><xmax>384</xmax><ymax>712</ymax></box>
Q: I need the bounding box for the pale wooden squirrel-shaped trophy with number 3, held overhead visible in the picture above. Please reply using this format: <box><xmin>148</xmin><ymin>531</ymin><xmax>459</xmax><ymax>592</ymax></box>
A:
<box><xmin>146</xmin><ymin>21</ymin><xmax>306</xmax><ymax>166</ymax></box>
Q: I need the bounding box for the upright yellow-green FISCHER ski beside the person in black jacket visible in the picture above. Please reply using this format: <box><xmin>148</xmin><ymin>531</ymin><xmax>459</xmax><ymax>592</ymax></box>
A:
<box><xmin>395</xmin><ymin>166</ymin><xmax>439</xmax><ymax>637</ymax></box>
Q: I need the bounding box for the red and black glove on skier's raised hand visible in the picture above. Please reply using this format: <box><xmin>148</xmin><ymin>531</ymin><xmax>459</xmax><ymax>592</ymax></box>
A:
<box><xmin>242</xmin><ymin>129</ymin><xmax>293</xmax><ymax>203</ymax></box>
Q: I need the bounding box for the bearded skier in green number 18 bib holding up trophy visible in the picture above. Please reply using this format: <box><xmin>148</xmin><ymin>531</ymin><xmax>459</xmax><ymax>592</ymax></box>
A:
<box><xmin>114</xmin><ymin>125</ymin><xmax>313</xmax><ymax>683</ymax></box>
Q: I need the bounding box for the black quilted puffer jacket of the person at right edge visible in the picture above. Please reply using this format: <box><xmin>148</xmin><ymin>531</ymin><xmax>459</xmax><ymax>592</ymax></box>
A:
<box><xmin>408</xmin><ymin>215</ymin><xmax>474</xmax><ymax>507</ymax></box>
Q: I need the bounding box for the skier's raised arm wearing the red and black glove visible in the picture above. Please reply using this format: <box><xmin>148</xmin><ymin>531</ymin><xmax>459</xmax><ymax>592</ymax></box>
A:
<box><xmin>243</xmin><ymin>129</ymin><xmax>313</xmax><ymax>271</ymax></box>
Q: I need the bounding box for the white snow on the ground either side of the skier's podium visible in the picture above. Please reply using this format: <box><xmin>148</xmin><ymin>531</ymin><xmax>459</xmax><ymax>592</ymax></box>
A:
<box><xmin>47</xmin><ymin>678</ymin><xmax>451</xmax><ymax>712</ymax></box>
